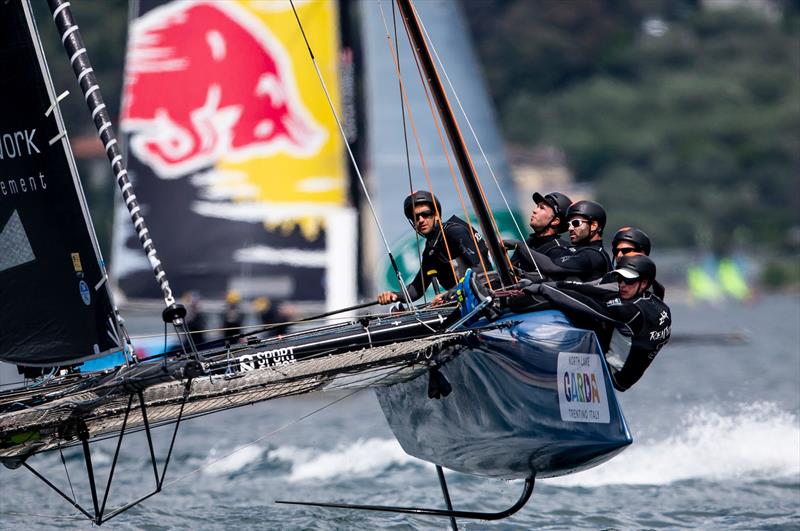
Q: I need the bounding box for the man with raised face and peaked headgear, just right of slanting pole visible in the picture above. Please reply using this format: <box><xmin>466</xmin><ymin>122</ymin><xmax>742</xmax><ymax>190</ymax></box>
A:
<box><xmin>503</xmin><ymin>192</ymin><xmax>572</xmax><ymax>271</ymax></box>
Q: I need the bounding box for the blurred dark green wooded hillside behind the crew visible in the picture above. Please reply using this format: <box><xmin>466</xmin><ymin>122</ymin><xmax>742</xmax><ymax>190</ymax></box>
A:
<box><xmin>464</xmin><ymin>0</ymin><xmax>800</xmax><ymax>252</ymax></box>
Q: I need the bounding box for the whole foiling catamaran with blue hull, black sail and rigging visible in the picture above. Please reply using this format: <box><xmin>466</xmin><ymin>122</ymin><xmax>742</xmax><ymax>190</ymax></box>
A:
<box><xmin>0</xmin><ymin>0</ymin><xmax>632</xmax><ymax>527</ymax></box>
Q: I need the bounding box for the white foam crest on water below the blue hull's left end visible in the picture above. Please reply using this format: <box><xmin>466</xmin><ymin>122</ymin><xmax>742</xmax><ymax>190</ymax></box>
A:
<box><xmin>270</xmin><ymin>438</ymin><xmax>416</xmax><ymax>481</ymax></box>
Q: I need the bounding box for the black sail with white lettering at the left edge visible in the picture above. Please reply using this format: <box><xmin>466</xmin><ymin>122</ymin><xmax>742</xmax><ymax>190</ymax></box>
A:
<box><xmin>0</xmin><ymin>0</ymin><xmax>120</xmax><ymax>366</ymax></box>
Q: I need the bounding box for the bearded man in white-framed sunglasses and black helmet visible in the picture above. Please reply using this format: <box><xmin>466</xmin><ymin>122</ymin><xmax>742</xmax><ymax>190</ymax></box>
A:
<box><xmin>525</xmin><ymin>201</ymin><xmax>611</xmax><ymax>282</ymax></box>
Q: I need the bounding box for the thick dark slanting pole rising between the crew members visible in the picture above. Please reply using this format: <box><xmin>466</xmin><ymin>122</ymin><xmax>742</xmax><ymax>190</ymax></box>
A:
<box><xmin>397</xmin><ymin>0</ymin><xmax>514</xmax><ymax>285</ymax></box>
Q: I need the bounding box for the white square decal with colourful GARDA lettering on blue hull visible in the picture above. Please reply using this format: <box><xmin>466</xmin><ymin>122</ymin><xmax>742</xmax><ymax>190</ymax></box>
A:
<box><xmin>556</xmin><ymin>352</ymin><xmax>610</xmax><ymax>424</ymax></box>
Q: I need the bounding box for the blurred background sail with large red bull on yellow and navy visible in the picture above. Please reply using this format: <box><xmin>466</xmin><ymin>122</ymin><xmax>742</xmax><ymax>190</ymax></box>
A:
<box><xmin>112</xmin><ymin>0</ymin><xmax>356</xmax><ymax>306</ymax></box>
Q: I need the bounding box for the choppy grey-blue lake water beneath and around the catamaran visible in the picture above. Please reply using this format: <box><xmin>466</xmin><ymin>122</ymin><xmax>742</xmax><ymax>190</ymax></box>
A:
<box><xmin>0</xmin><ymin>296</ymin><xmax>800</xmax><ymax>530</ymax></box>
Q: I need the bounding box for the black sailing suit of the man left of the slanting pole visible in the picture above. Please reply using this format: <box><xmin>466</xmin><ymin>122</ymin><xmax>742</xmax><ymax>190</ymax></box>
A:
<box><xmin>394</xmin><ymin>216</ymin><xmax>492</xmax><ymax>301</ymax></box>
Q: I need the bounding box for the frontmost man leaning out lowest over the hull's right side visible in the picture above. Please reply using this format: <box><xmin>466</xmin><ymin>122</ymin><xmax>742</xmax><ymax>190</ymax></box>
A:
<box><xmin>525</xmin><ymin>255</ymin><xmax>672</xmax><ymax>391</ymax></box>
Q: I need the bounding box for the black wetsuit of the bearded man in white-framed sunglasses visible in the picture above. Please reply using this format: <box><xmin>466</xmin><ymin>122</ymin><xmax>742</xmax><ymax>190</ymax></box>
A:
<box><xmin>523</xmin><ymin>240</ymin><xmax>611</xmax><ymax>282</ymax></box>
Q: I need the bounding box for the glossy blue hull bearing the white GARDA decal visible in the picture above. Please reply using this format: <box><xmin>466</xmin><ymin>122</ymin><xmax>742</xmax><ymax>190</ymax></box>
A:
<box><xmin>376</xmin><ymin>310</ymin><xmax>633</xmax><ymax>479</ymax></box>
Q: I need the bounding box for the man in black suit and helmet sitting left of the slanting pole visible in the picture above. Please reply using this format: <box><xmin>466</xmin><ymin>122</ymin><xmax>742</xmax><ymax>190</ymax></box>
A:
<box><xmin>377</xmin><ymin>190</ymin><xmax>492</xmax><ymax>304</ymax></box>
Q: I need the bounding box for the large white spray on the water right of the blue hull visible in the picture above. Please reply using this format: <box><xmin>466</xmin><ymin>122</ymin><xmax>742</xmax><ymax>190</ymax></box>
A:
<box><xmin>544</xmin><ymin>402</ymin><xmax>800</xmax><ymax>487</ymax></box>
